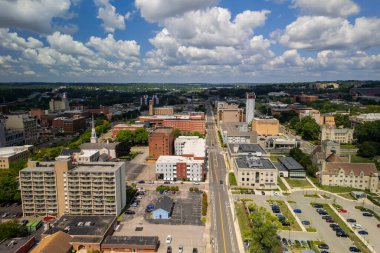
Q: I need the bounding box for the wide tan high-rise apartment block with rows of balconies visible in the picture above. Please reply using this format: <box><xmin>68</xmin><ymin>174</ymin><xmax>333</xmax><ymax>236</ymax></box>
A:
<box><xmin>19</xmin><ymin>159</ymin><xmax>126</xmax><ymax>216</ymax></box>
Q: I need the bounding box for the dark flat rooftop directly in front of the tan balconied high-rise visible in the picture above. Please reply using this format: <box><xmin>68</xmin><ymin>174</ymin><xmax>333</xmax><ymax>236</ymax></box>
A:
<box><xmin>44</xmin><ymin>215</ymin><xmax>116</xmax><ymax>237</ymax></box>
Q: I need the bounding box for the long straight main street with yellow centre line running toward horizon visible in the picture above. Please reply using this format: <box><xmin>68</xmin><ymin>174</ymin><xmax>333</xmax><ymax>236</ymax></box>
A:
<box><xmin>206</xmin><ymin>105</ymin><xmax>239</xmax><ymax>253</ymax></box>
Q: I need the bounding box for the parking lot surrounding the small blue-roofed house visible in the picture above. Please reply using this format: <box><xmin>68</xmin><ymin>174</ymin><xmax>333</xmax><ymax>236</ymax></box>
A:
<box><xmin>118</xmin><ymin>188</ymin><xmax>206</xmax><ymax>253</ymax></box>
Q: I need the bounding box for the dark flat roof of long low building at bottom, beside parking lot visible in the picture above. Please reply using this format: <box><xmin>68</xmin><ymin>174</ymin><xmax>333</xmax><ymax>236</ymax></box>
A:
<box><xmin>102</xmin><ymin>235</ymin><xmax>159</xmax><ymax>249</ymax></box>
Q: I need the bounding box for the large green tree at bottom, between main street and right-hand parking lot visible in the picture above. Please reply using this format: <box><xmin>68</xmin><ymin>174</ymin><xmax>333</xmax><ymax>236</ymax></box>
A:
<box><xmin>249</xmin><ymin>204</ymin><xmax>280</xmax><ymax>253</ymax></box>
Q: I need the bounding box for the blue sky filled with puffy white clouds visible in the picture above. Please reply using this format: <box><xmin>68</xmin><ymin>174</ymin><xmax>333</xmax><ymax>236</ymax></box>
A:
<box><xmin>0</xmin><ymin>0</ymin><xmax>380</xmax><ymax>83</ymax></box>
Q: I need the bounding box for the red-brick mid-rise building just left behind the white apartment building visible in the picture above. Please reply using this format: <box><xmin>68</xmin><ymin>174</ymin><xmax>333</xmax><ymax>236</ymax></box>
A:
<box><xmin>149</xmin><ymin>127</ymin><xmax>174</xmax><ymax>159</ymax></box>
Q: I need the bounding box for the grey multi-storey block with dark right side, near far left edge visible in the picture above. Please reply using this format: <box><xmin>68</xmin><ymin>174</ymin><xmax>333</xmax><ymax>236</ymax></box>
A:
<box><xmin>5</xmin><ymin>114</ymin><xmax>38</xmax><ymax>144</ymax></box>
